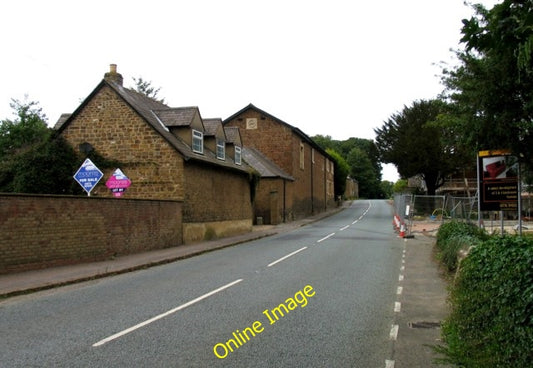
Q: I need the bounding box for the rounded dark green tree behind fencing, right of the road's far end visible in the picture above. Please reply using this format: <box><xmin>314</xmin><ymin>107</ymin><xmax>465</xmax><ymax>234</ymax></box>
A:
<box><xmin>374</xmin><ymin>100</ymin><xmax>456</xmax><ymax>195</ymax></box>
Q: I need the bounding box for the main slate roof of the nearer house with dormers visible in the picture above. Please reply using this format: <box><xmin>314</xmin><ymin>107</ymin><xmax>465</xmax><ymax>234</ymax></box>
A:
<box><xmin>55</xmin><ymin>79</ymin><xmax>250</xmax><ymax>173</ymax></box>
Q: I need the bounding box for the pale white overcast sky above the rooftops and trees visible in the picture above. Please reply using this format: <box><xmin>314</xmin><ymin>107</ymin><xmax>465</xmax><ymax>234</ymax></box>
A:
<box><xmin>0</xmin><ymin>0</ymin><xmax>499</xmax><ymax>181</ymax></box>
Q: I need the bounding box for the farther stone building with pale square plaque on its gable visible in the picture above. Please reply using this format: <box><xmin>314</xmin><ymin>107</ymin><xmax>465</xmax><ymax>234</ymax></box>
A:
<box><xmin>223</xmin><ymin>104</ymin><xmax>335</xmax><ymax>224</ymax></box>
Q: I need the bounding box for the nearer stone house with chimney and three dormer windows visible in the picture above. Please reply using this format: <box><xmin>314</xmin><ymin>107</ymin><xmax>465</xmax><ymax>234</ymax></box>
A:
<box><xmin>56</xmin><ymin>64</ymin><xmax>253</xmax><ymax>243</ymax></box>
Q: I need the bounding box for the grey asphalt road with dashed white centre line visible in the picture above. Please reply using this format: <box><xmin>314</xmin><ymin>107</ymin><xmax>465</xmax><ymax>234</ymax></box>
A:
<box><xmin>0</xmin><ymin>200</ymin><xmax>403</xmax><ymax>368</ymax></box>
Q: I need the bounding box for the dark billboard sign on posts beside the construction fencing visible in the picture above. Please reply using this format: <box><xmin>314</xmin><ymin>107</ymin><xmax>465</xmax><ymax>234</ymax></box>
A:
<box><xmin>478</xmin><ymin>150</ymin><xmax>518</xmax><ymax>211</ymax></box>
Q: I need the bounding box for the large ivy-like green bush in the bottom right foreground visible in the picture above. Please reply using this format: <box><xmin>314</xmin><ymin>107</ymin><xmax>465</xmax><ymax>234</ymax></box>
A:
<box><xmin>439</xmin><ymin>237</ymin><xmax>533</xmax><ymax>368</ymax></box>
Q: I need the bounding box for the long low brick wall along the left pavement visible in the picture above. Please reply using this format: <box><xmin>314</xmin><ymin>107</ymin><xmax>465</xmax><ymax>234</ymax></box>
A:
<box><xmin>0</xmin><ymin>194</ymin><xmax>182</xmax><ymax>274</ymax></box>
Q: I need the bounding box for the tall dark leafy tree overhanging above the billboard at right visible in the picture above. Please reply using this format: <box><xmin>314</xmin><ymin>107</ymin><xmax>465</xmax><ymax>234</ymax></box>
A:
<box><xmin>443</xmin><ymin>0</ymin><xmax>533</xmax><ymax>168</ymax></box>
